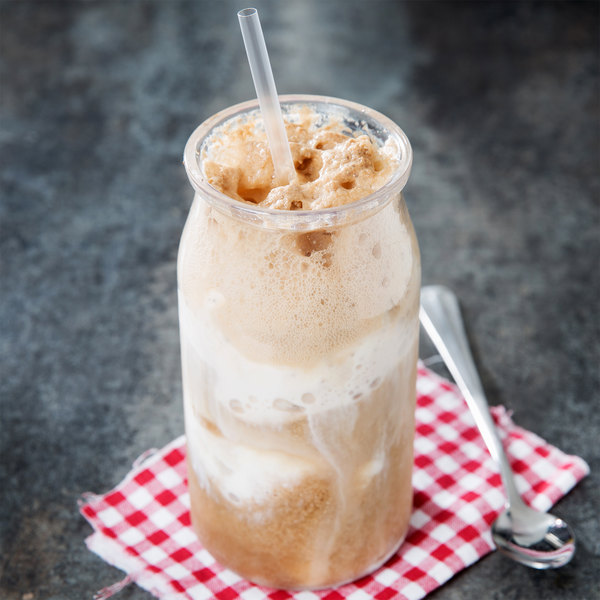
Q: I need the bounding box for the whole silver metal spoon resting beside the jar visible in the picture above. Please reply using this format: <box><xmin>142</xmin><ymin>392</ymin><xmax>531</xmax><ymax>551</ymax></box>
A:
<box><xmin>419</xmin><ymin>285</ymin><xmax>575</xmax><ymax>569</ymax></box>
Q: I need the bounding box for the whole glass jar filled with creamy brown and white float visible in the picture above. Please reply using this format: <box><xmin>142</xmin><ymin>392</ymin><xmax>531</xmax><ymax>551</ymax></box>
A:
<box><xmin>178</xmin><ymin>96</ymin><xmax>420</xmax><ymax>589</ymax></box>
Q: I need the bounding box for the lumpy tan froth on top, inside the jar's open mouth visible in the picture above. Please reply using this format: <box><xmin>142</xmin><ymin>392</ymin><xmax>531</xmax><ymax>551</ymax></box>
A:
<box><xmin>203</xmin><ymin>107</ymin><xmax>398</xmax><ymax>210</ymax></box>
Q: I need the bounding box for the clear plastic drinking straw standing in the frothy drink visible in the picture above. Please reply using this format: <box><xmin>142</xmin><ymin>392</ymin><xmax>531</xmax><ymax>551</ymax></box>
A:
<box><xmin>238</xmin><ymin>8</ymin><xmax>296</xmax><ymax>185</ymax></box>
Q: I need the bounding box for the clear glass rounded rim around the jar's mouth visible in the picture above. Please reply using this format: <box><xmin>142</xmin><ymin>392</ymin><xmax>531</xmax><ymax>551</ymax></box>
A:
<box><xmin>183</xmin><ymin>94</ymin><xmax>412</xmax><ymax>229</ymax></box>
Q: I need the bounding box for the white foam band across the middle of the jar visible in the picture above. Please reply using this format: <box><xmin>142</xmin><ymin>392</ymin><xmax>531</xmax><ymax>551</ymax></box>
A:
<box><xmin>179</xmin><ymin>288</ymin><xmax>414</xmax><ymax>423</ymax></box>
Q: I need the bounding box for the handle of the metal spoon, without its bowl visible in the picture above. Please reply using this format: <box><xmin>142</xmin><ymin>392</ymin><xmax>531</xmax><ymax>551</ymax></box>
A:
<box><xmin>419</xmin><ymin>285</ymin><xmax>523</xmax><ymax>507</ymax></box>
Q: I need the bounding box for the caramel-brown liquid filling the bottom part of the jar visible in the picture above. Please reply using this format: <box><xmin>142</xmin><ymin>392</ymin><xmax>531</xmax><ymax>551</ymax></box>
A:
<box><xmin>188</xmin><ymin>340</ymin><xmax>416</xmax><ymax>589</ymax></box>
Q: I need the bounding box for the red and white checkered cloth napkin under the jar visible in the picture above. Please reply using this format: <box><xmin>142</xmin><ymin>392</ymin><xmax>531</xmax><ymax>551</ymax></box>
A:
<box><xmin>80</xmin><ymin>366</ymin><xmax>589</xmax><ymax>600</ymax></box>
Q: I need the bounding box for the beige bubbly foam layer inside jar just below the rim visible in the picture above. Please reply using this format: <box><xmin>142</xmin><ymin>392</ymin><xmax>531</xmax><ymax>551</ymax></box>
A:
<box><xmin>179</xmin><ymin>201</ymin><xmax>418</xmax><ymax>366</ymax></box>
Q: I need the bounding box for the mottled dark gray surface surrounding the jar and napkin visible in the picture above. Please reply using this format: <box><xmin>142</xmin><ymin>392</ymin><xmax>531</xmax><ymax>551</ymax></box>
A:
<box><xmin>0</xmin><ymin>0</ymin><xmax>600</xmax><ymax>600</ymax></box>
